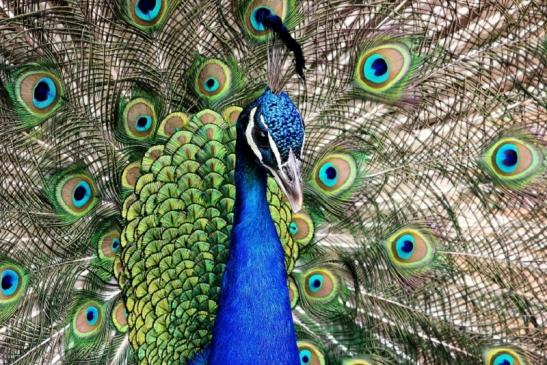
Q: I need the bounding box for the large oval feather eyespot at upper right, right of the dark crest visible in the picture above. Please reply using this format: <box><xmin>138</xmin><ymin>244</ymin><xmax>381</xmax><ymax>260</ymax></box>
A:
<box><xmin>355</xmin><ymin>43</ymin><xmax>412</xmax><ymax>98</ymax></box>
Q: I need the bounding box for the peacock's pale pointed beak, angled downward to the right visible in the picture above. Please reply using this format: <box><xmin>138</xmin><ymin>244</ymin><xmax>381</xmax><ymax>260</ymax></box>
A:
<box><xmin>272</xmin><ymin>150</ymin><xmax>304</xmax><ymax>213</ymax></box>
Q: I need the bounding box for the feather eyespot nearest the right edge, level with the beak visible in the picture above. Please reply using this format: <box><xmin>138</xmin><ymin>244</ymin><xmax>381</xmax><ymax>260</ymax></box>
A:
<box><xmin>482</xmin><ymin>137</ymin><xmax>544</xmax><ymax>188</ymax></box>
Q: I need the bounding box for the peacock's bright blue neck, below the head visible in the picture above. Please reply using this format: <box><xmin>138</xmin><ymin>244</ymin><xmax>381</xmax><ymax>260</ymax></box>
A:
<box><xmin>209</xmin><ymin>136</ymin><xmax>300</xmax><ymax>365</ymax></box>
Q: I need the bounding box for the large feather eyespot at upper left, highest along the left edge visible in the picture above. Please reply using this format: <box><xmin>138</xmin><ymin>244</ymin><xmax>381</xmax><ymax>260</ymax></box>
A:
<box><xmin>6</xmin><ymin>64</ymin><xmax>64</xmax><ymax>127</ymax></box>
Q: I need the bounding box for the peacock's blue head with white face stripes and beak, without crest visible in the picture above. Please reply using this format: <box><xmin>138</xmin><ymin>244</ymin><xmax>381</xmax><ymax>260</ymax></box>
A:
<box><xmin>240</xmin><ymin>89</ymin><xmax>304</xmax><ymax>212</ymax></box>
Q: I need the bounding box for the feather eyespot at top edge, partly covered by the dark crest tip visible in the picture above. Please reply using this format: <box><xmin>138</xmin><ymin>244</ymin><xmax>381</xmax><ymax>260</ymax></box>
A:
<box><xmin>243</xmin><ymin>0</ymin><xmax>288</xmax><ymax>41</ymax></box>
